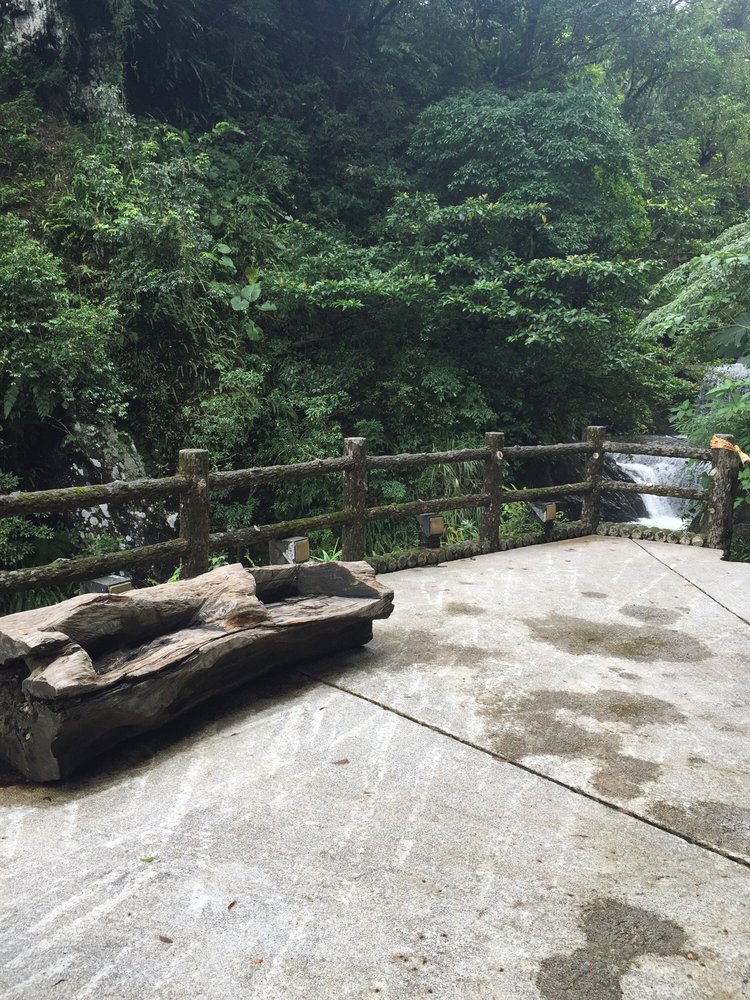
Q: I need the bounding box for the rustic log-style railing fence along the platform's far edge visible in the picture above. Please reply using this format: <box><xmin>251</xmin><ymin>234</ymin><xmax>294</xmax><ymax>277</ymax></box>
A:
<box><xmin>0</xmin><ymin>427</ymin><xmax>739</xmax><ymax>593</ymax></box>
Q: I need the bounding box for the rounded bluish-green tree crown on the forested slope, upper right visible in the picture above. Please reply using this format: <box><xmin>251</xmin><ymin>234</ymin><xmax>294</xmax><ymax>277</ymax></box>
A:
<box><xmin>411</xmin><ymin>85</ymin><xmax>647</xmax><ymax>257</ymax></box>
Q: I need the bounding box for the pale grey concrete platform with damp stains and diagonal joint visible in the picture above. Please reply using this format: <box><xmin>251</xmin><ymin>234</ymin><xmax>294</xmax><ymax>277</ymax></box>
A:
<box><xmin>0</xmin><ymin>538</ymin><xmax>750</xmax><ymax>1000</ymax></box>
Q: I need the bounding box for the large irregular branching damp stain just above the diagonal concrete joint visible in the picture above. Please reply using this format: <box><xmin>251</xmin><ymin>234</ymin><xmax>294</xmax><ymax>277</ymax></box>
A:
<box><xmin>479</xmin><ymin>689</ymin><xmax>686</xmax><ymax>801</ymax></box>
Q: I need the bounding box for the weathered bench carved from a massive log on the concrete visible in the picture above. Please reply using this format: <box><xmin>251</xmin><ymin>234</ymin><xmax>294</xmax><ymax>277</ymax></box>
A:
<box><xmin>0</xmin><ymin>563</ymin><xmax>393</xmax><ymax>781</ymax></box>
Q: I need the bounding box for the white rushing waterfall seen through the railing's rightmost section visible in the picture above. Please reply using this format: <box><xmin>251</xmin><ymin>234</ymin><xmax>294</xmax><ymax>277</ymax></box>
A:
<box><xmin>612</xmin><ymin>436</ymin><xmax>704</xmax><ymax>531</ymax></box>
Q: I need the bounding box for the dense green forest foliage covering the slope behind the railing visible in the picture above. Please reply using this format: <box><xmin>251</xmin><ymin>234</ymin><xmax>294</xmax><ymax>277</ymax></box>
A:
<box><xmin>0</xmin><ymin>0</ymin><xmax>750</xmax><ymax>556</ymax></box>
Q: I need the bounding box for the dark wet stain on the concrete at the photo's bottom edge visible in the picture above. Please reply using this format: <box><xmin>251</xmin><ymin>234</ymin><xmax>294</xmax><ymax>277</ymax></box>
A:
<box><xmin>536</xmin><ymin>899</ymin><xmax>687</xmax><ymax>1000</ymax></box>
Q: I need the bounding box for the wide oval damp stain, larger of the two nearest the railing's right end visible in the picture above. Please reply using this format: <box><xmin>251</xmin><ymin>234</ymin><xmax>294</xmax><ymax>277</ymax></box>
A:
<box><xmin>524</xmin><ymin>614</ymin><xmax>711</xmax><ymax>663</ymax></box>
